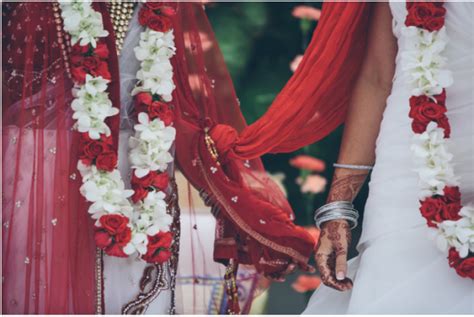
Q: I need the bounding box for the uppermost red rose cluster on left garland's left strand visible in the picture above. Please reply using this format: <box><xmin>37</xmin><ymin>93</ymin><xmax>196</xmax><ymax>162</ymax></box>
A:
<box><xmin>71</xmin><ymin>42</ymin><xmax>111</xmax><ymax>84</ymax></box>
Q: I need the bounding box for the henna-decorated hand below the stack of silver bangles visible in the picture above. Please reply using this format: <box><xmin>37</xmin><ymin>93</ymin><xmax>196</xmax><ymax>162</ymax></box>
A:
<box><xmin>316</xmin><ymin>220</ymin><xmax>352</xmax><ymax>291</ymax></box>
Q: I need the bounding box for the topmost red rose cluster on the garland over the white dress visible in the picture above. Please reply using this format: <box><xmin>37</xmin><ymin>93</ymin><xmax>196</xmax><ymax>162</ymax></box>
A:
<box><xmin>405</xmin><ymin>2</ymin><xmax>446</xmax><ymax>32</ymax></box>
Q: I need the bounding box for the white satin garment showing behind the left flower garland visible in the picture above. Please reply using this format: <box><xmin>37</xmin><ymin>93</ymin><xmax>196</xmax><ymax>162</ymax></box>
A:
<box><xmin>104</xmin><ymin>4</ymin><xmax>171</xmax><ymax>315</ymax></box>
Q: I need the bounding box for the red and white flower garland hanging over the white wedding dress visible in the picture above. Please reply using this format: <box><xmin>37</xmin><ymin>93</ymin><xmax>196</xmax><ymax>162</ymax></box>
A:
<box><xmin>401</xmin><ymin>2</ymin><xmax>474</xmax><ymax>279</ymax></box>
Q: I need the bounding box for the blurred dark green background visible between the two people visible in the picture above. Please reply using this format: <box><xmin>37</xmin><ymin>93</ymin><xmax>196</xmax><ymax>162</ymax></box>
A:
<box><xmin>206</xmin><ymin>2</ymin><xmax>367</xmax><ymax>314</ymax></box>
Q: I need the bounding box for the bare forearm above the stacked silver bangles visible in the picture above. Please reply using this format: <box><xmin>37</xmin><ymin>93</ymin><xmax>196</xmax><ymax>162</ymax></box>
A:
<box><xmin>328</xmin><ymin>3</ymin><xmax>397</xmax><ymax>202</ymax></box>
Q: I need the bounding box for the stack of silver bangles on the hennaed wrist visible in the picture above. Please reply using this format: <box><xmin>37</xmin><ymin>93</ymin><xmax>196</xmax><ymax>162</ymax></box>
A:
<box><xmin>314</xmin><ymin>201</ymin><xmax>359</xmax><ymax>229</ymax></box>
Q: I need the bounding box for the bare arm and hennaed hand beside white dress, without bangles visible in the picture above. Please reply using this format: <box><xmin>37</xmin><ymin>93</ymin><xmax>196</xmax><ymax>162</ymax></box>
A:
<box><xmin>315</xmin><ymin>3</ymin><xmax>397</xmax><ymax>291</ymax></box>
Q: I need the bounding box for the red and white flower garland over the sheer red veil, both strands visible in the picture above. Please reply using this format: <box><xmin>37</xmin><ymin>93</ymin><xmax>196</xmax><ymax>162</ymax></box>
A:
<box><xmin>60</xmin><ymin>0</ymin><xmax>176</xmax><ymax>263</ymax></box>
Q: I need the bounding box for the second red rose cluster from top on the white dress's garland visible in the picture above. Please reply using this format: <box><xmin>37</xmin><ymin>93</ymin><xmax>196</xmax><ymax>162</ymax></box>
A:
<box><xmin>409</xmin><ymin>89</ymin><xmax>451</xmax><ymax>138</ymax></box>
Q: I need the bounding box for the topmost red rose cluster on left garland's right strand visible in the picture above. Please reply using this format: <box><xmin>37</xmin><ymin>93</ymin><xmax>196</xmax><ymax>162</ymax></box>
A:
<box><xmin>138</xmin><ymin>2</ymin><xmax>176</xmax><ymax>32</ymax></box>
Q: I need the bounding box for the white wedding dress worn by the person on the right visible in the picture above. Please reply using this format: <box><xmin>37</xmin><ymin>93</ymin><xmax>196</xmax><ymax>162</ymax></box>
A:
<box><xmin>304</xmin><ymin>2</ymin><xmax>474</xmax><ymax>314</ymax></box>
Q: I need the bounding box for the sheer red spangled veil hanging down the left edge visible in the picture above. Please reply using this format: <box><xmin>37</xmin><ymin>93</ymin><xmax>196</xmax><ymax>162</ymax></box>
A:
<box><xmin>2</xmin><ymin>2</ymin><xmax>119</xmax><ymax>314</ymax></box>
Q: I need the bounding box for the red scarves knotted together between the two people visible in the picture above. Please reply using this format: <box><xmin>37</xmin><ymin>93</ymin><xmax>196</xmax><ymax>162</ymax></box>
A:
<box><xmin>173</xmin><ymin>3</ymin><xmax>370</xmax><ymax>276</ymax></box>
